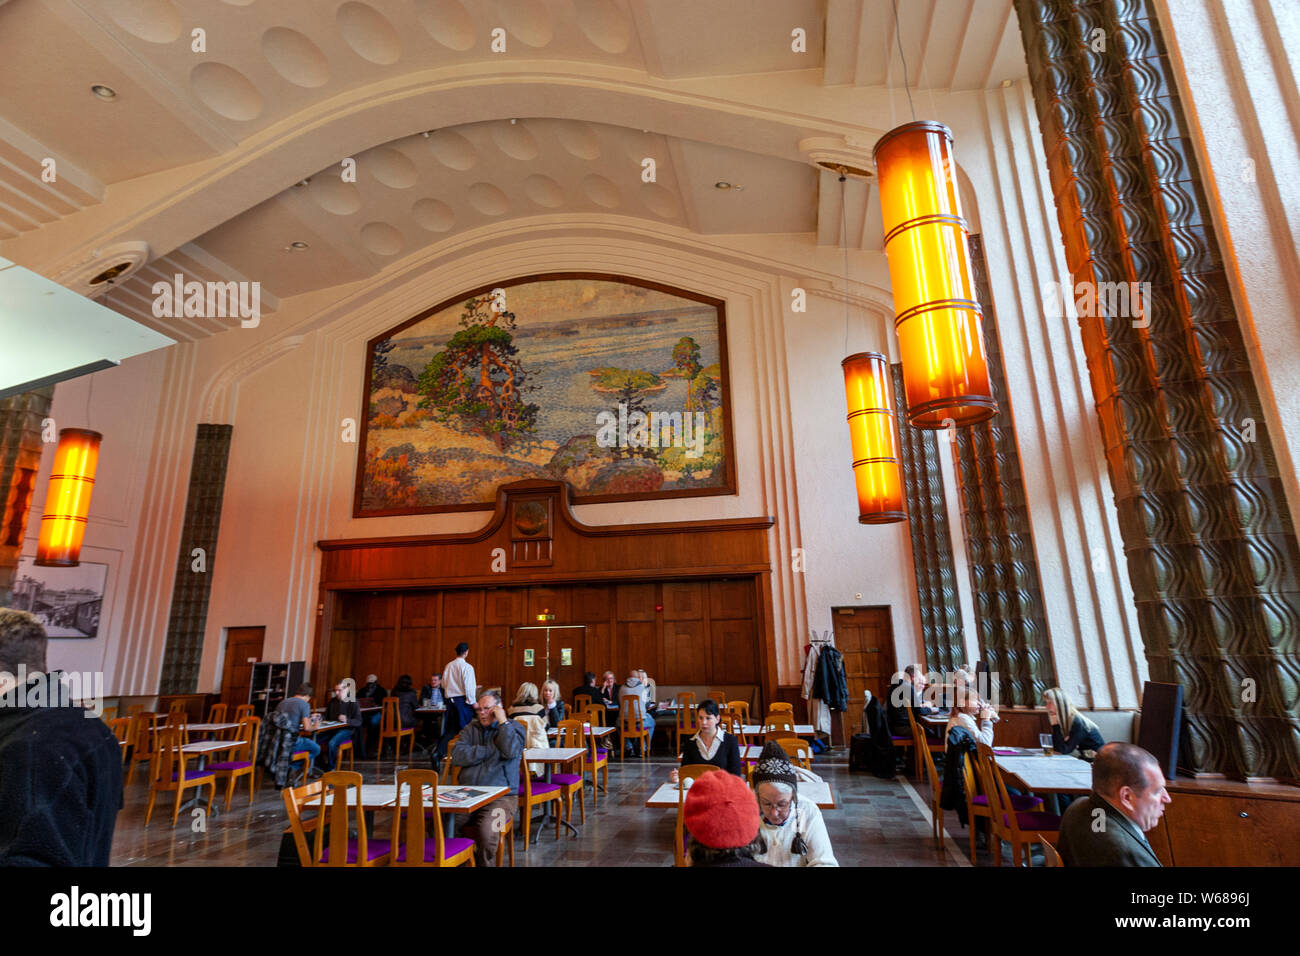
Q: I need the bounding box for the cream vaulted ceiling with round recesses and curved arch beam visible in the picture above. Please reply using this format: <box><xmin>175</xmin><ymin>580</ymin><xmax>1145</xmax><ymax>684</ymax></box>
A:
<box><xmin>0</xmin><ymin>0</ymin><xmax>1026</xmax><ymax>339</ymax></box>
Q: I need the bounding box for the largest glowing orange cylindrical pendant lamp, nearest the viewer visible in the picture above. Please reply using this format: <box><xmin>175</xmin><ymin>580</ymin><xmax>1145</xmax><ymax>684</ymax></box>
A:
<box><xmin>872</xmin><ymin>121</ymin><xmax>997</xmax><ymax>428</ymax></box>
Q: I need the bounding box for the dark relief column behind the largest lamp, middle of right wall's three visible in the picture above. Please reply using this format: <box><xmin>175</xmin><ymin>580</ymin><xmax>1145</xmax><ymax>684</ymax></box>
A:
<box><xmin>956</xmin><ymin>235</ymin><xmax>1056</xmax><ymax>708</ymax></box>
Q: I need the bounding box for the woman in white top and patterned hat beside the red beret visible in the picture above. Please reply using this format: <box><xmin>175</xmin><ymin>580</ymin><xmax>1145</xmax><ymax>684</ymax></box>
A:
<box><xmin>754</xmin><ymin>741</ymin><xmax>840</xmax><ymax>866</ymax></box>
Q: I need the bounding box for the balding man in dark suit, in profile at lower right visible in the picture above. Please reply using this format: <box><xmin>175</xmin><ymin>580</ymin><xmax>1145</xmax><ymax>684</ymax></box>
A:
<box><xmin>1057</xmin><ymin>744</ymin><xmax>1170</xmax><ymax>866</ymax></box>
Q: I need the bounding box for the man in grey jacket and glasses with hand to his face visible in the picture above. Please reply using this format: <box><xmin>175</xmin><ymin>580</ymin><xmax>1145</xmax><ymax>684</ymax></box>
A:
<box><xmin>451</xmin><ymin>691</ymin><xmax>524</xmax><ymax>866</ymax></box>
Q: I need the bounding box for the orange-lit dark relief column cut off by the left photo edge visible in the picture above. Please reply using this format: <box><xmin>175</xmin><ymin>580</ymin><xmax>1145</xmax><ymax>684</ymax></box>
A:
<box><xmin>0</xmin><ymin>385</ymin><xmax>55</xmax><ymax>607</ymax></box>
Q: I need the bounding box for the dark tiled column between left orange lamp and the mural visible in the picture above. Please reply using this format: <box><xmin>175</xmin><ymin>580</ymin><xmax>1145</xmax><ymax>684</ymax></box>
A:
<box><xmin>159</xmin><ymin>425</ymin><xmax>234</xmax><ymax>693</ymax></box>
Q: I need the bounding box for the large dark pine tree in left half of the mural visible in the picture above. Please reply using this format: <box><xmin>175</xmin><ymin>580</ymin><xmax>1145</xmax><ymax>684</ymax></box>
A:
<box><xmin>419</xmin><ymin>294</ymin><xmax>538</xmax><ymax>450</ymax></box>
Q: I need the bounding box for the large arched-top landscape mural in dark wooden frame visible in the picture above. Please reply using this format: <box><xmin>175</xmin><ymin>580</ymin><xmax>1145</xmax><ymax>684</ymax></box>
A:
<box><xmin>352</xmin><ymin>272</ymin><xmax>736</xmax><ymax>518</ymax></box>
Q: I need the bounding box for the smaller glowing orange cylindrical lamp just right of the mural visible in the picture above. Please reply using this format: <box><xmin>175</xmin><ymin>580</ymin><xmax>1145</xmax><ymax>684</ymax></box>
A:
<box><xmin>840</xmin><ymin>352</ymin><xmax>907</xmax><ymax>524</ymax></box>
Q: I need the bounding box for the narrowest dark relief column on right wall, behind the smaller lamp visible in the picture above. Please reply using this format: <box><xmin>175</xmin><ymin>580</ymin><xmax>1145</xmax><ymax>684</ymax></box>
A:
<box><xmin>889</xmin><ymin>363</ymin><xmax>966</xmax><ymax>672</ymax></box>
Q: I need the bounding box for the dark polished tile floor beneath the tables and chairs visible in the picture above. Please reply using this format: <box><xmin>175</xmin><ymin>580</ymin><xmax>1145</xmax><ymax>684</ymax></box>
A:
<box><xmin>112</xmin><ymin>749</ymin><xmax>1010</xmax><ymax>866</ymax></box>
